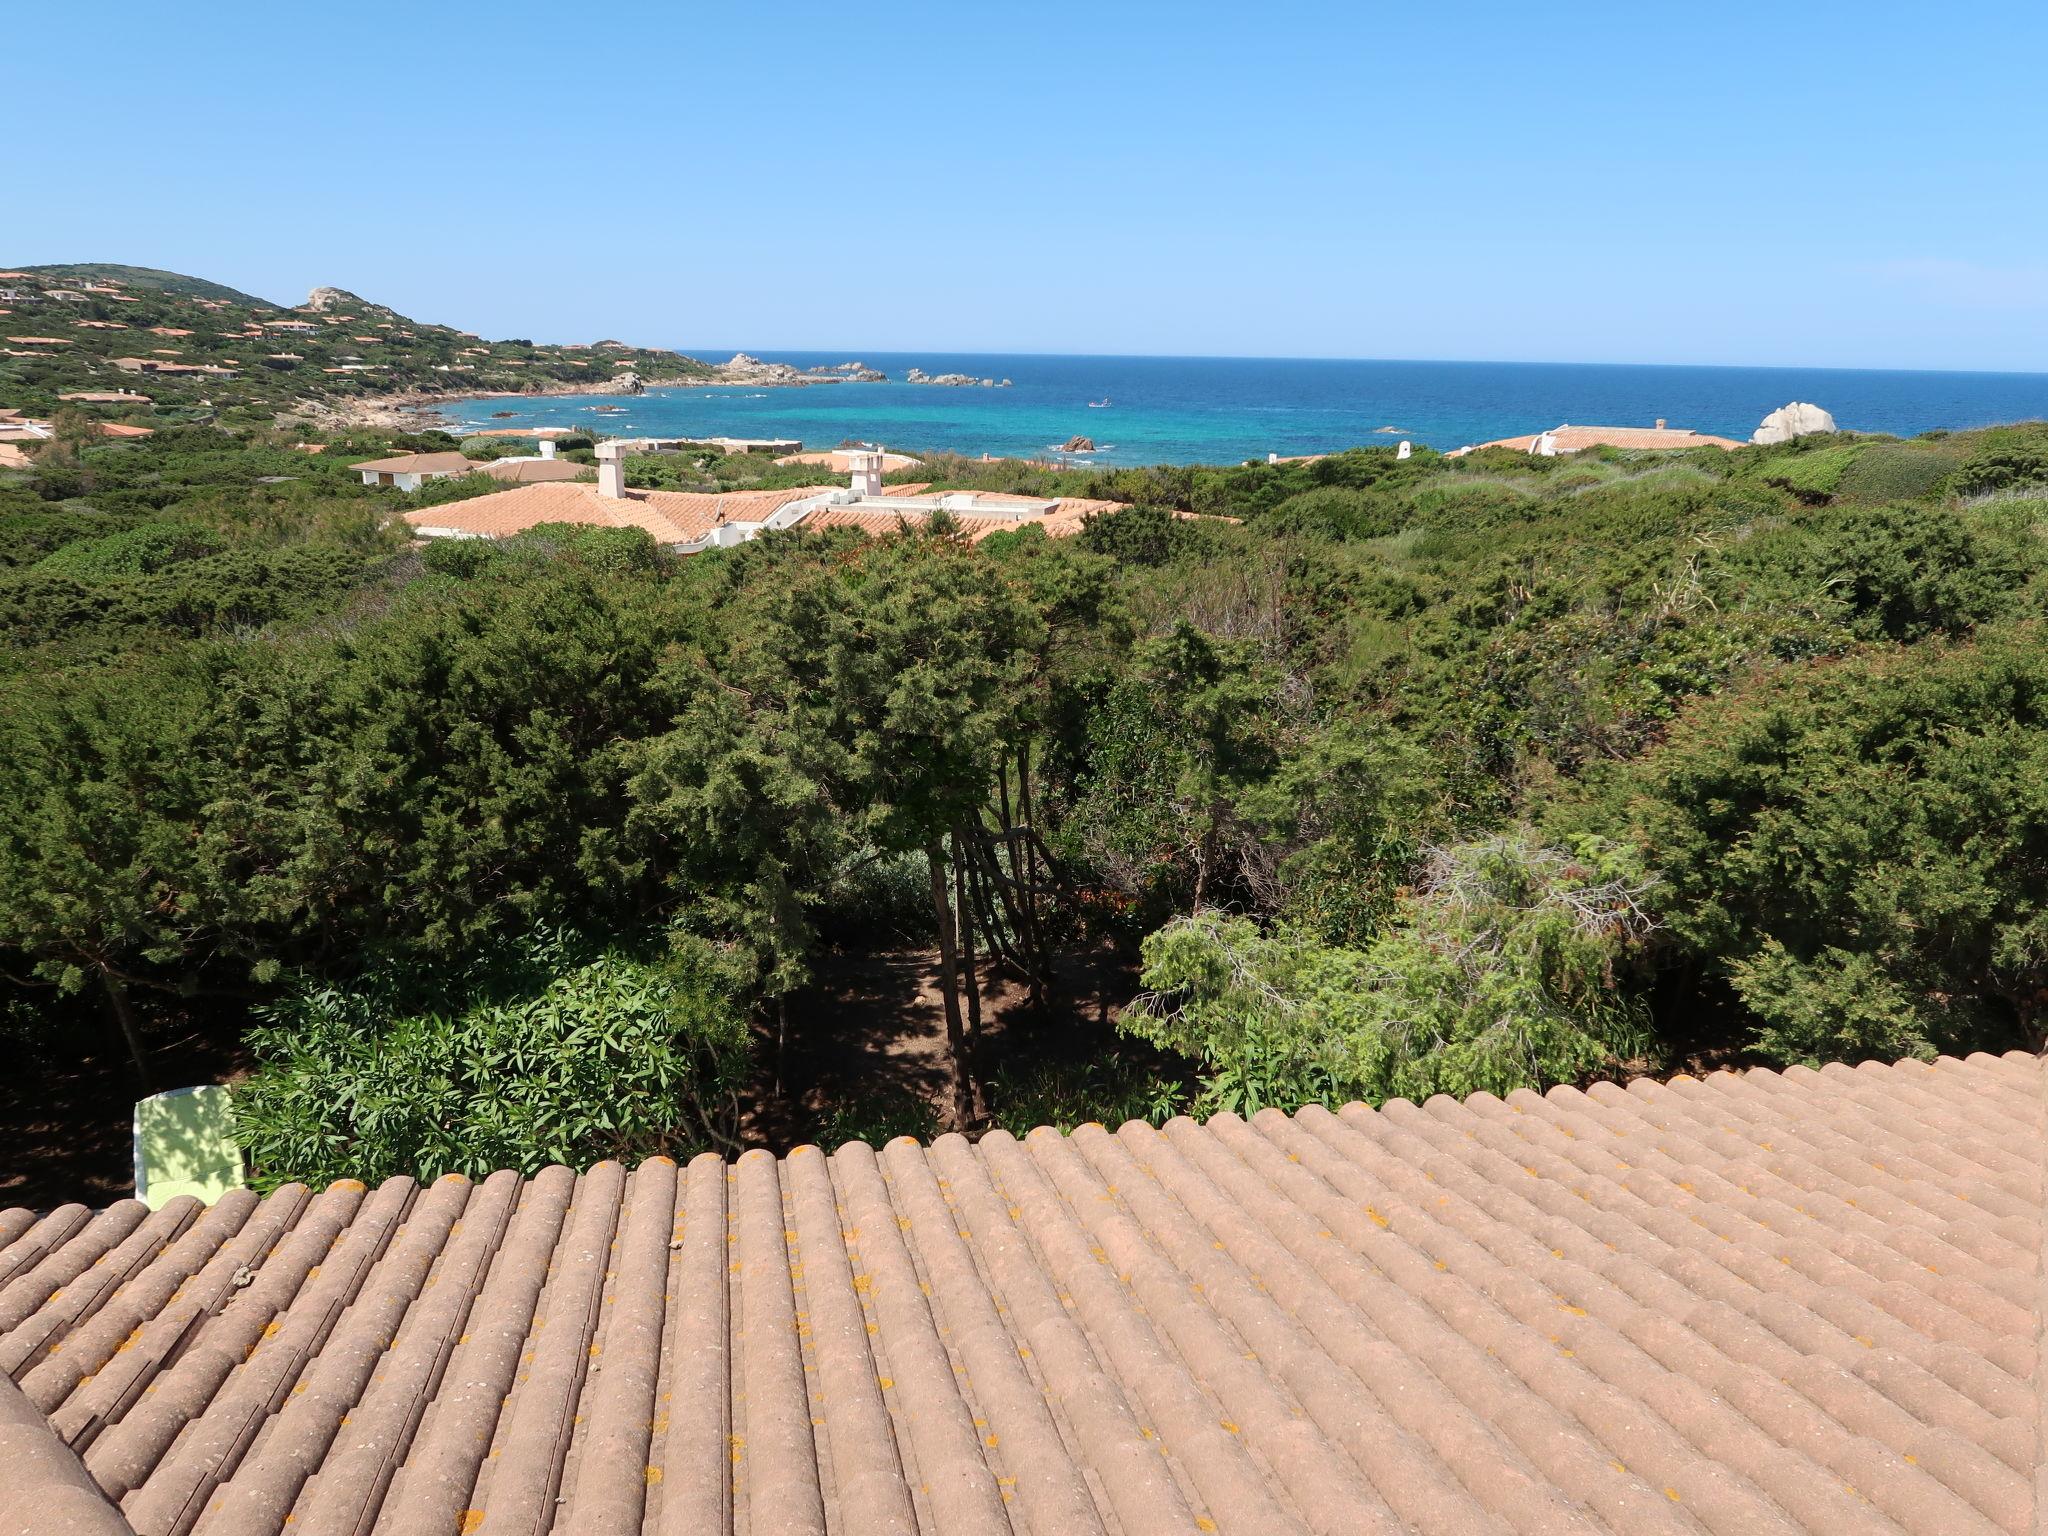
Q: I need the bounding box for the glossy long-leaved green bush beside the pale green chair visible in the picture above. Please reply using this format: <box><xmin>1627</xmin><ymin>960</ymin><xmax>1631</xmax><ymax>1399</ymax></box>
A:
<box><xmin>233</xmin><ymin>938</ymin><xmax>748</xmax><ymax>1188</ymax></box>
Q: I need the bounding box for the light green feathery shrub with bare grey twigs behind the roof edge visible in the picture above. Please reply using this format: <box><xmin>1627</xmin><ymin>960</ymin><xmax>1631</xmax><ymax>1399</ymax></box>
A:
<box><xmin>1118</xmin><ymin>836</ymin><xmax>1655</xmax><ymax>1114</ymax></box>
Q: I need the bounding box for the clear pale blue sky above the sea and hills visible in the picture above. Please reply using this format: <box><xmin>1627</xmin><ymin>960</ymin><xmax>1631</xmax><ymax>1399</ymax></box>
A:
<box><xmin>0</xmin><ymin>0</ymin><xmax>2048</xmax><ymax>371</ymax></box>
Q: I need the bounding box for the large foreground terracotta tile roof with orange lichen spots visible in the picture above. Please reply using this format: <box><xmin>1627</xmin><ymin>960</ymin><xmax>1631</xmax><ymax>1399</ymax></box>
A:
<box><xmin>0</xmin><ymin>1055</ymin><xmax>2048</xmax><ymax>1536</ymax></box>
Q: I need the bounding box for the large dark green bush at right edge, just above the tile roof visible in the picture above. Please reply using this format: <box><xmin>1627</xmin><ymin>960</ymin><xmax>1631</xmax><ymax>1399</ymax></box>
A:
<box><xmin>1618</xmin><ymin>625</ymin><xmax>2048</xmax><ymax>1061</ymax></box>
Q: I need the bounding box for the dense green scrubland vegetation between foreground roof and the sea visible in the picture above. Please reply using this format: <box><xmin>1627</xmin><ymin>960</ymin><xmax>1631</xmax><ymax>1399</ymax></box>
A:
<box><xmin>0</xmin><ymin>411</ymin><xmax>2048</xmax><ymax>1180</ymax></box>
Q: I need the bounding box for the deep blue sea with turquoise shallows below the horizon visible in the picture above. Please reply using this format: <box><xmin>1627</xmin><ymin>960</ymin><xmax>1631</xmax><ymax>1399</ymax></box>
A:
<box><xmin>432</xmin><ymin>348</ymin><xmax>2048</xmax><ymax>465</ymax></box>
